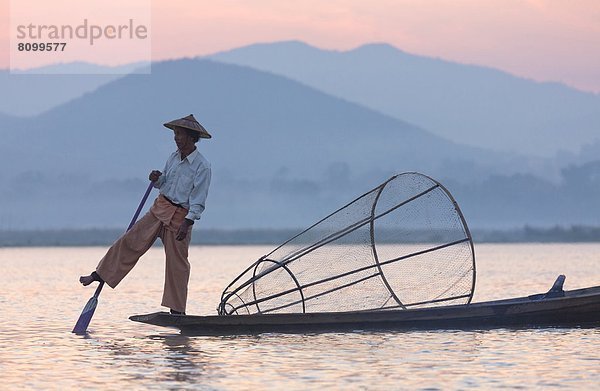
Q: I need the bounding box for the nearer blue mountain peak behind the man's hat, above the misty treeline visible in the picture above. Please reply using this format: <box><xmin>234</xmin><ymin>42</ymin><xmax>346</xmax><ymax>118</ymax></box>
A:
<box><xmin>26</xmin><ymin>60</ymin><xmax>519</xmax><ymax>178</ymax></box>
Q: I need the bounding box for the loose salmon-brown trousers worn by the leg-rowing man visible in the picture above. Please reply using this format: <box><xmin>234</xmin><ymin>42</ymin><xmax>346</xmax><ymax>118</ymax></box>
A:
<box><xmin>96</xmin><ymin>195</ymin><xmax>192</xmax><ymax>312</ymax></box>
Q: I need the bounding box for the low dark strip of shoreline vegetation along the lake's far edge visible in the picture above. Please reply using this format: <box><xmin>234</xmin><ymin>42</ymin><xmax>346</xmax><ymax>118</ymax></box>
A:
<box><xmin>0</xmin><ymin>225</ymin><xmax>600</xmax><ymax>247</ymax></box>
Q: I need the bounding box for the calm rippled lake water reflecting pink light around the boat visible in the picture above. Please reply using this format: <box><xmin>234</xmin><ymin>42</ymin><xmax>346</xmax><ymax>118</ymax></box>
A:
<box><xmin>0</xmin><ymin>244</ymin><xmax>600</xmax><ymax>390</ymax></box>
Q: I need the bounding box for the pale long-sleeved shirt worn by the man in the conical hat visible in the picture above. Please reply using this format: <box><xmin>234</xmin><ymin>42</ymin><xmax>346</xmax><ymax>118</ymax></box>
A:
<box><xmin>154</xmin><ymin>149</ymin><xmax>211</xmax><ymax>220</ymax></box>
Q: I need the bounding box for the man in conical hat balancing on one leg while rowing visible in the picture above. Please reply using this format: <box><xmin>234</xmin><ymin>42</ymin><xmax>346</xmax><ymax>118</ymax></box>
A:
<box><xmin>79</xmin><ymin>114</ymin><xmax>212</xmax><ymax>315</ymax></box>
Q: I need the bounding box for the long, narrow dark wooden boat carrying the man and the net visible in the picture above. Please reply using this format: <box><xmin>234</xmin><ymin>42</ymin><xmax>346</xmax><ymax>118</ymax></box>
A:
<box><xmin>130</xmin><ymin>276</ymin><xmax>600</xmax><ymax>335</ymax></box>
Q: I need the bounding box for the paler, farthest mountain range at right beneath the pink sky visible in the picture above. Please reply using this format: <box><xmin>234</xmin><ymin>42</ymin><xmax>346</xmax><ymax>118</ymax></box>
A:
<box><xmin>210</xmin><ymin>41</ymin><xmax>600</xmax><ymax>156</ymax></box>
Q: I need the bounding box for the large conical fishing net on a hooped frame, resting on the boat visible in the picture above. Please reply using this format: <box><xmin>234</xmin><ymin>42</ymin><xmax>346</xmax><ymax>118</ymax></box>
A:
<box><xmin>218</xmin><ymin>173</ymin><xmax>475</xmax><ymax>315</ymax></box>
